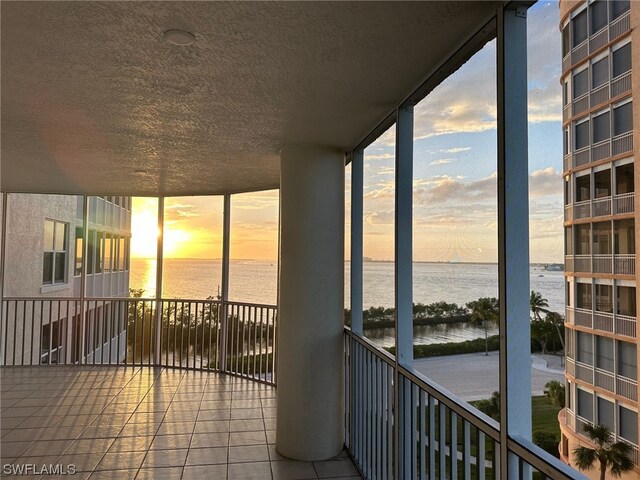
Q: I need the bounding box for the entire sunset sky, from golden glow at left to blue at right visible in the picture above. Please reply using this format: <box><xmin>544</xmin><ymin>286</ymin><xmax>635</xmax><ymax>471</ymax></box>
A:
<box><xmin>132</xmin><ymin>2</ymin><xmax>563</xmax><ymax>262</ymax></box>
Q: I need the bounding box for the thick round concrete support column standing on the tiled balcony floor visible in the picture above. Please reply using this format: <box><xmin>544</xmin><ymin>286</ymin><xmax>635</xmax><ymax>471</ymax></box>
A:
<box><xmin>276</xmin><ymin>146</ymin><xmax>344</xmax><ymax>461</ymax></box>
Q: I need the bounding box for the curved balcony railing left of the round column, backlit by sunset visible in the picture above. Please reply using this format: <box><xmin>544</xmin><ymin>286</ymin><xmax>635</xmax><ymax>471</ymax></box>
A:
<box><xmin>2</xmin><ymin>298</ymin><xmax>277</xmax><ymax>385</ymax></box>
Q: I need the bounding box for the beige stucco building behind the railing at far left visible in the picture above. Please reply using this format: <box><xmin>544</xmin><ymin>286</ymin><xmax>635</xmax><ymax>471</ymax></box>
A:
<box><xmin>0</xmin><ymin>194</ymin><xmax>131</xmax><ymax>365</ymax></box>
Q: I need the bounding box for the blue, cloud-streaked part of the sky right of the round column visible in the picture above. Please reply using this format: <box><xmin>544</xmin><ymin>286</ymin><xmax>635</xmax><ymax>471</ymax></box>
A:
<box><xmin>350</xmin><ymin>2</ymin><xmax>563</xmax><ymax>262</ymax></box>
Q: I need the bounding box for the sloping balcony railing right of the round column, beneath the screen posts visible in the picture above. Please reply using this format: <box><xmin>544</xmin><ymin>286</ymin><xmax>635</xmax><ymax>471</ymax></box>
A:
<box><xmin>345</xmin><ymin>329</ymin><xmax>575</xmax><ymax>479</ymax></box>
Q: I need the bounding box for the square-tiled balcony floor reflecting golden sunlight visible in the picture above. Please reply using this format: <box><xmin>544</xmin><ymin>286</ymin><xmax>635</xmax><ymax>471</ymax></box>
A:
<box><xmin>0</xmin><ymin>366</ymin><xmax>361</xmax><ymax>480</ymax></box>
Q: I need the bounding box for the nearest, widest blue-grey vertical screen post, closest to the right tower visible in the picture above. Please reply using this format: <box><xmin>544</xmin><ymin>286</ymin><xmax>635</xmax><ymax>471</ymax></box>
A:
<box><xmin>498</xmin><ymin>6</ymin><xmax>531</xmax><ymax>478</ymax></box>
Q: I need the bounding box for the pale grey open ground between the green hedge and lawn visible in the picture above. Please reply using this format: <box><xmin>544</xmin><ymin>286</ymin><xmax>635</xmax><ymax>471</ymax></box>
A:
<box><xmin>414</xmin><ymin>352</ymin><xmax>564</xmax><ymax>401</ymax></box>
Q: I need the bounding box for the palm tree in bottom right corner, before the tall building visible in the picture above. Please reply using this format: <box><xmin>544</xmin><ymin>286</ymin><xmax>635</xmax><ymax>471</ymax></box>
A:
<box><xmin>573</xmin><ymin>425</ymin><xmax>633</xmax><ymax>480</ymax></box>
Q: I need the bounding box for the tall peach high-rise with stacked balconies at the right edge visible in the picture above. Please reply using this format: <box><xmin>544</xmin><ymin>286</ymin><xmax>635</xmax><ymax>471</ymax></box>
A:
<box><xmin>559</xmin><ymin>0</ymin><xmax>640</xmax><ymax>478</ymax></box>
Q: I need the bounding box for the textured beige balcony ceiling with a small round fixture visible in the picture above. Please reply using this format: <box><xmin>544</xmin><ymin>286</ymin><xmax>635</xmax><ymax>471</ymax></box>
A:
<box><xmin>0</xmin><ymin>1</ymin><xmax>497</xmax><ymax>195</ymax></box>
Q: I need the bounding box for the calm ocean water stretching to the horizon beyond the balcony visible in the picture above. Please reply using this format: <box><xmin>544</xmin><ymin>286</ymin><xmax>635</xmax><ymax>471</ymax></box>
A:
<box><xmin>130</xmin><ymin>258</ymin><xmax>565</xmax><ymax>313</ymax></box>
